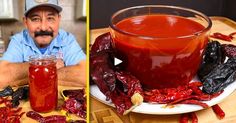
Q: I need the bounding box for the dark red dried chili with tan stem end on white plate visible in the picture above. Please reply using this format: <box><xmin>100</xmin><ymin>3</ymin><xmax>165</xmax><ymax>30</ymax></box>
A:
<box><xmin>106</xmin><ymin>71</ymin><xmax>143</xmax><ymax>114</ymax></box>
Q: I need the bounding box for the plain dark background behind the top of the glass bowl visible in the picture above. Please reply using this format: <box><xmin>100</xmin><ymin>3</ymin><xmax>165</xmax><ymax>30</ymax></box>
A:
<box><xmin>90</xmin><ymin>0</ymin><xmax>236</xmax><ymax>29</ymax></box>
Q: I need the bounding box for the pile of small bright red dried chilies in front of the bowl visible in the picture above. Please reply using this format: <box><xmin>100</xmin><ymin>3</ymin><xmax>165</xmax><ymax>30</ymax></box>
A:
<box><xmin>144</xmin><ymin>82</ymin><xmax>223</xmax><ymax>108</ymax></box>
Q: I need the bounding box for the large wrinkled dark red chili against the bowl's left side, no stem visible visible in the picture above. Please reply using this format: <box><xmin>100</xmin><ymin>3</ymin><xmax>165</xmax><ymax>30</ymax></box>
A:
<box><xmin>90</xmin><ymin>33</ymin><xmax>115</xmax><ymax>100</ymax></box>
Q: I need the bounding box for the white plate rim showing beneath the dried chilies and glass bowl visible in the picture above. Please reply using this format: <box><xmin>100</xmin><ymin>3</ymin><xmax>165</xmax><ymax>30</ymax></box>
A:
<box><xmin>90</xmin><ymin>82</ymin><xmax>236</xmax><ymax>115</ymax></box>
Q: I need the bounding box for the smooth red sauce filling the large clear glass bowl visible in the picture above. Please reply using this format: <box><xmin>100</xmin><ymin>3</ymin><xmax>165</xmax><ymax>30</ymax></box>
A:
<box><xmin>113</xmin><ymin>15</ymin><xmax>207</xmax><ymax>88</ymax></box>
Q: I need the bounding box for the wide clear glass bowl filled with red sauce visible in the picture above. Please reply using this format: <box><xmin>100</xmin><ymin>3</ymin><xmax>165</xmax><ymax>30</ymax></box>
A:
<box><xmin>110</xmin><ymin>5</ymin><xmax>212</xmax><ymax>89</ymax></box>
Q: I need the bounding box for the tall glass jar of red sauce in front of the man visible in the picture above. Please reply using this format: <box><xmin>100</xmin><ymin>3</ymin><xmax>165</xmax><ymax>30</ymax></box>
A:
<box><xmin>29</xmin><ymin>55</ymin><xmax>58</xmax><ymax>112</ymax></box>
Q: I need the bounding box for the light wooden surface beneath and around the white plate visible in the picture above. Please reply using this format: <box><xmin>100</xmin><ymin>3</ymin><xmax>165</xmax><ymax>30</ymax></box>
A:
<box><xmin>90</xmin><ymin>17</ymin><xmax>236</xmax><ymax>123</ymax></box>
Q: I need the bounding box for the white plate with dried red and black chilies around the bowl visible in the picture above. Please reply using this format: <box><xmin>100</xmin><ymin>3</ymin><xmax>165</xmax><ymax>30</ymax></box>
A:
<box><xmin>90</xmin><ymin>33</ymin><xmax>236</xmax><ymax>115</ymax></box>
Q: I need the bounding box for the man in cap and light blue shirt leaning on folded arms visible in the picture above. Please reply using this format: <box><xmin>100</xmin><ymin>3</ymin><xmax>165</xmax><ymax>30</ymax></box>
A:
<box><xmin>0</xmin><ymin>0</ymin><xmax>86</xmax><ymax>87</ymax></box>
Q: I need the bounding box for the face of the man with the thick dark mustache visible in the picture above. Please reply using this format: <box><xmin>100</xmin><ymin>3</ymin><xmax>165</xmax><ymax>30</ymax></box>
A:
<box><xmin>24</xmin><ymin>7</ymin><xmax>61</xmax><ymax>48</ymax></box>
